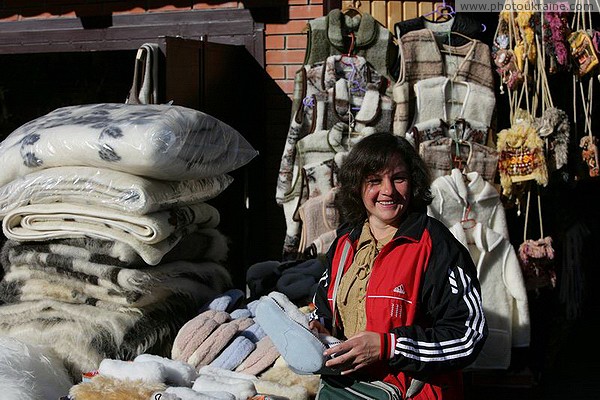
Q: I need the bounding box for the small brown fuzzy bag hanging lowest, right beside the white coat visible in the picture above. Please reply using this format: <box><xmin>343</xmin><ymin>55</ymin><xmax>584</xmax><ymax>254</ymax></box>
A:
<box><xmin>519</xmin><ymin>189</ymin><xmax>556</xmax><ymax>290</ymax></box>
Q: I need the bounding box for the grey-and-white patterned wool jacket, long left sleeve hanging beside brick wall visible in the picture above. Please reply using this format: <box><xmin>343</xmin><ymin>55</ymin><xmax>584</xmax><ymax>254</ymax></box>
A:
<box><xmin>275</xmin><ymin>55</ymin><xmax>394</xmax><ymax>204</ymax></box>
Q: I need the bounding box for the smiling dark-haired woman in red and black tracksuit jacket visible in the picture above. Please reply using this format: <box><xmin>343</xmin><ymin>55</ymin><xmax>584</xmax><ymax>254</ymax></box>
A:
<box><xmin>310</xmin><ymin>133</ymin><xmax>487</xmax><ymax>400</ymax></box>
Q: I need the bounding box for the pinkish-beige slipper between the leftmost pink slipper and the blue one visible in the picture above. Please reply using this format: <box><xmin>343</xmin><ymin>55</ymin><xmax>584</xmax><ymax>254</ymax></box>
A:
<box><xmin>187</xmin><ymin>318</ymin><xmax>254</xmax><ymax>370</ymax></box>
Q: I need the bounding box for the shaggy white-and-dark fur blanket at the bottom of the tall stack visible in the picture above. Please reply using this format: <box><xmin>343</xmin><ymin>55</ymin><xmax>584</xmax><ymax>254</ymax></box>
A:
<box><xmin>0</xmin><ymin>294</ymin><xmax>207</xmax><ymax>379</ymax></box>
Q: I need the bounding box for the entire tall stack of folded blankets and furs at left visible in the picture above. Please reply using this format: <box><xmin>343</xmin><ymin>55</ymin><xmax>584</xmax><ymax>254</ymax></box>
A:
<box><xmin>0</xmin><ymin>104</ymin><xmax>257</xmax><ymax>377</ymax></box>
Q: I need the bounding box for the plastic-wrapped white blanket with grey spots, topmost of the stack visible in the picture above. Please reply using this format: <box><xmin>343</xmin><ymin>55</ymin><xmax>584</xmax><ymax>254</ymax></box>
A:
<box><xmin>0</xmin><ymin>103</ymin><xmax>258</xmax><ymax>185</ymax></box>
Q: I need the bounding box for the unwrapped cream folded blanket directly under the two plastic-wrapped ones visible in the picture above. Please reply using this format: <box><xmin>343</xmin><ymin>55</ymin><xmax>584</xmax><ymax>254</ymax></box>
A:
<box><xmin>2</xmin><ymin>203</ymin><xmax>220</xmax><ymax>265</ymax></box>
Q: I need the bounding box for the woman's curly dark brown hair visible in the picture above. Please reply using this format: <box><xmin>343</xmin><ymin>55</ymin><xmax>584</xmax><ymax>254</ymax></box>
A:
<box><xmin>335</xmin><ymin>132</ymin><xmax>433</xmax><ymax>225</ymax></box>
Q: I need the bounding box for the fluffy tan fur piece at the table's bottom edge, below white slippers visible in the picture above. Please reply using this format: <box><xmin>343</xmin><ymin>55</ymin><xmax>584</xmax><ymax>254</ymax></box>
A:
<box><xmin>69</xmin><ymin>375</ymin><xmax>166</xmax><ymax>400</ymax></box>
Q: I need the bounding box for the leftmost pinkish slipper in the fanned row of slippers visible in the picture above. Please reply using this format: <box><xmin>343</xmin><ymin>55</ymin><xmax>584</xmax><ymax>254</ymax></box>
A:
<box><xmin>171</xmin><ymin>310</ymin><xmax>230</xmax><ymax>362</ymax></box>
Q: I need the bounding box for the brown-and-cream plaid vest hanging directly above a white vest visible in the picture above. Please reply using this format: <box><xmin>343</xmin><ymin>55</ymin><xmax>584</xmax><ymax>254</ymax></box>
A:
<box><xmin>393</xmin><ymin>29</ymin><xmax>494</xmax><ymax>136</ymax></box>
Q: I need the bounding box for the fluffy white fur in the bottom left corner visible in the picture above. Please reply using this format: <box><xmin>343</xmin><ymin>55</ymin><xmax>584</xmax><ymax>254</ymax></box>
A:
<box><xmin>0</xmin><ymin>336</ymin><xmax>73</xmax><ymax>400</ymax></box>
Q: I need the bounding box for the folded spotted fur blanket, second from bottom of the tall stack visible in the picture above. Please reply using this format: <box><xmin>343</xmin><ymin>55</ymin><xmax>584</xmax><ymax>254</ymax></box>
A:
<box><xmin>0</xmin><ymin>261</ymin><xmax>231</xmax><ymax>307</ymax></box>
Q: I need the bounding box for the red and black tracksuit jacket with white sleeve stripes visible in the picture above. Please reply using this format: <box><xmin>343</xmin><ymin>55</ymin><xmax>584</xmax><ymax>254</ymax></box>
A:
<box><xmin>312</xmin><ymin>213</ymin><xmax>487</xmax><ymax>399</ymax></box>
